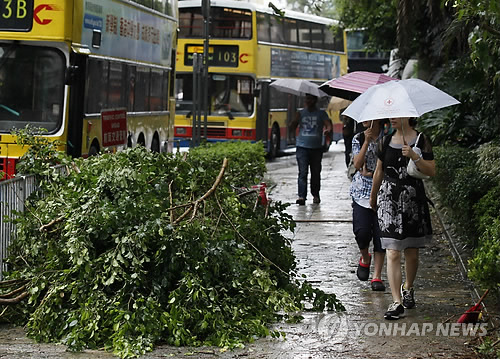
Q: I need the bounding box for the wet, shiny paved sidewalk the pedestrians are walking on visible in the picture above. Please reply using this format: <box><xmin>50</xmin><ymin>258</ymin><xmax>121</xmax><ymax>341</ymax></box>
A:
<box><xmin>0</xmin><ymin>143</ymin><xmax>475</xmax><ymax>359</ymax></box>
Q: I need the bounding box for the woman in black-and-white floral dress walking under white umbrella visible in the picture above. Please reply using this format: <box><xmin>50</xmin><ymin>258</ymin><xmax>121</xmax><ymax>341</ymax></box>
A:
<box><xmin>370</xmin><ymin>118</ymin><xmax>435</xmax><ymax>319</ymax></box>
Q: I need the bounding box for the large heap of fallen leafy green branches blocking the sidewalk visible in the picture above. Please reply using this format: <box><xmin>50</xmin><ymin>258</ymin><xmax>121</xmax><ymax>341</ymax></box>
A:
<box><xmin>3</xmin><ymin>143</ymin><xmax>342</xmax><ymax>357</ymax></box>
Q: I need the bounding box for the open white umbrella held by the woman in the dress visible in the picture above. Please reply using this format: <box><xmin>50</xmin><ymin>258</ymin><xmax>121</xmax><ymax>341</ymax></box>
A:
<box><xmin>343</xmin><ymin>79</ymin><xmax>460</xmax><ymax>122</ymax></box>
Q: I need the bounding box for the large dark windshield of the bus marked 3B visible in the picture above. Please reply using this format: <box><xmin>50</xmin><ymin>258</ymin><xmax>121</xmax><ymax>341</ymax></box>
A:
<box><xmin>0</xmin><ymin>43</ymin><xmax>65</xmax><ymax>133</ymax></box>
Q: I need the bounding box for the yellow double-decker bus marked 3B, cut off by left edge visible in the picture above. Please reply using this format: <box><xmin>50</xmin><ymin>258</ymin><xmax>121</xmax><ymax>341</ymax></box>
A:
<box><xmin>0</xmin><ymin>0</ymin><xmax>178</xmax><ymax>176</ymax></box>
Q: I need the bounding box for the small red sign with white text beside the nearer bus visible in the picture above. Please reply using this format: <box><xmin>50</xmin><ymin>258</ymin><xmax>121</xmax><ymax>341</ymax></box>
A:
<box><xmin>101</xmin><ymin>108</ymin><xmax>127</xmax><ymax>147</ymax></box>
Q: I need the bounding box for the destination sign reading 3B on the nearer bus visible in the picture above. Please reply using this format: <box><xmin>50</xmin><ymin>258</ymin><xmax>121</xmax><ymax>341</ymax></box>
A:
<box><xmin>0</xmin><ymin>0</ymin><xmax>34</xmax><ymax>32</ymax></box>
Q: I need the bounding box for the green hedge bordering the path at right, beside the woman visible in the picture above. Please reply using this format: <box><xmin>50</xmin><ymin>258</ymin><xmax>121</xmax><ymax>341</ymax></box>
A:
<box><xmin>434</xmin><ymin>141</ymin><xmax>500</xmax><ymax>288</ymax></box>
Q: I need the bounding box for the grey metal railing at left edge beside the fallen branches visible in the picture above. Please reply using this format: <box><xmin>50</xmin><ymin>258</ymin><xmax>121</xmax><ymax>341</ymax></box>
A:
<box><xmin>0</xmin><ymin>175</ymin><xmax>36</xmax><ymax>280</ymax></box>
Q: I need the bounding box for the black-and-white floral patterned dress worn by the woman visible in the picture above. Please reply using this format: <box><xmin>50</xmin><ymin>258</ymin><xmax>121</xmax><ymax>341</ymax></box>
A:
<box><xmin>377</xmin><ymin>134</ymin><xmax>434</xmax><ymax>250</ymax></box>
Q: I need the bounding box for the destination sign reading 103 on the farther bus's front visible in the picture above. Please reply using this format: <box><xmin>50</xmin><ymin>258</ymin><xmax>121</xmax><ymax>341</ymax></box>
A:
<box><xmin>184</xmin><ymin>44</ymin><xmax>239</xmax><ymax>67</ymax></box>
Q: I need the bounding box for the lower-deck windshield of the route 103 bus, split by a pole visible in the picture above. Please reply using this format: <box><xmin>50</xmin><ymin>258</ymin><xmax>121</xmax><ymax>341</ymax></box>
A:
<box><xmin>176</xmin><ymin>74</ymin><xmax>254</xmax><ymax>116</ymax></box>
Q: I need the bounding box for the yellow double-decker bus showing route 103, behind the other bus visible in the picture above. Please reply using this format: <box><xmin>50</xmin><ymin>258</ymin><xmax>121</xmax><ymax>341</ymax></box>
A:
<box><xmin>175</xmin><ymin>0</ymin><xmax>347</xmax><ymax>156</ymax></box>
